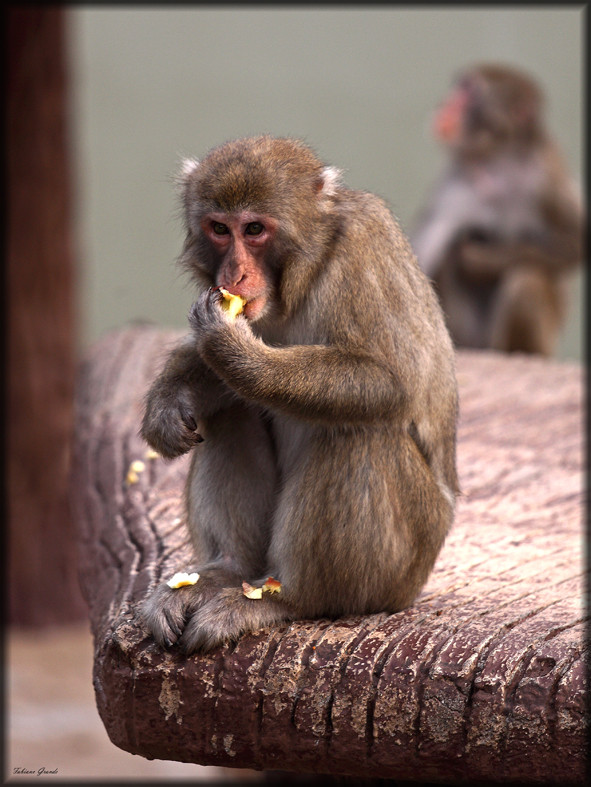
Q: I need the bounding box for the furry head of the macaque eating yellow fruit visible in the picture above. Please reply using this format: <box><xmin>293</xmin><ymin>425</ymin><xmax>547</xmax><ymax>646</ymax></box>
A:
<box><xmin>179</xmin><ymin>136</ymin><xmax>339</xmax><ymax>320</ymax></box>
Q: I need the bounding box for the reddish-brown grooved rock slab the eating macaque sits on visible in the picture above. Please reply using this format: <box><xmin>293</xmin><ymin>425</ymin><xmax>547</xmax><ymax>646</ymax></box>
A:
<box><xmin>73</xmin><ymin>326</ymin><xmax>587</xmax><ymax>783</ymax></box>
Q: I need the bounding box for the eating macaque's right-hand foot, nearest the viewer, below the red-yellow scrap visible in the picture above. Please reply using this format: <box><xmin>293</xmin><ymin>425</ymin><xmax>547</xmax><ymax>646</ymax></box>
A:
<box><xmin>179</xmin><ymin>587</ymin><xmax>294</xmax><ymax>653</ymax></box>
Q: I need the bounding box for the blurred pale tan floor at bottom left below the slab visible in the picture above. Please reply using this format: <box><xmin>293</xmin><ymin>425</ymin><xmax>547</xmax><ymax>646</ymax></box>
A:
<box><xmin>4</xmin><ymin>623</ymin><xmax>263</xmax><ymax>785</ymax></box>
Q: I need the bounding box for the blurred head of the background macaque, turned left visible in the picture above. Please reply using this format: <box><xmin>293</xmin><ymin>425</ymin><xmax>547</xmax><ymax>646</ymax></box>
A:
<box><xmin>434</xmin><ymin>64</ymin><xmax>543</xmax><ymax>157</ymax></box>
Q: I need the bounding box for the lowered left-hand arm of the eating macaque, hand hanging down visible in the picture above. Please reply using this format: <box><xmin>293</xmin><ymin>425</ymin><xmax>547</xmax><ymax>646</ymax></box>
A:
<box><xmin>141</xmin><ymin>340</ymin><xmax>236</xmax><ymax>459</ymax></box>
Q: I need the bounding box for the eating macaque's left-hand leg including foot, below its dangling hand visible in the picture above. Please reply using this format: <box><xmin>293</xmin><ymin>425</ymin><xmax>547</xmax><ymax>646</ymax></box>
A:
<box><xmin>140</xmin><ymin>403</ymin><xmax>276</xmax><ymax>651</ymax></box>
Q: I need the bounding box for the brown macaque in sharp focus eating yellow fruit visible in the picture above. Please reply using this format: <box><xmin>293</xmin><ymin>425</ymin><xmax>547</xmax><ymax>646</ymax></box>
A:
<box><xmin>141</xmin><ymin>136</ymin><xmax>458</xmax><ymax>653</ymax></box>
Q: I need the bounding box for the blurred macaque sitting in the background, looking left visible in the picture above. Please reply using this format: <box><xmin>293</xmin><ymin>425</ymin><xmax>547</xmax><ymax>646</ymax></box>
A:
<box><xmin>411</xmin><ymin>65</ymin><xmax>583</xmax><ymax>355</ymax></box>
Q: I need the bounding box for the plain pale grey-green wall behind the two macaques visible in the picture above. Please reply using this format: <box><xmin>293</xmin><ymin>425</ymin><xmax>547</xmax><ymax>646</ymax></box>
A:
<box><xmin>69</xmin><ymin>5</ymin><xmax>584</xmax><ymax>358</ymax></box>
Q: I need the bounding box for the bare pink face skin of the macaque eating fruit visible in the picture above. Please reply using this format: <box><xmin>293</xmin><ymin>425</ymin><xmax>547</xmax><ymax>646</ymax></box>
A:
<box><xmin>201</xmin><ymin>211</ymin><xmax>277</xmax><ymax>320</ymax></box>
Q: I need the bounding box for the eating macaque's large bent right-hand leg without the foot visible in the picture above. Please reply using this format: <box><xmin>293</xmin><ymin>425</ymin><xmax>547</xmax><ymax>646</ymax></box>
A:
<box><xmin>269</xmin><ymin>424</ymin><xmax>454</xmax><ymax>618</ymax></box>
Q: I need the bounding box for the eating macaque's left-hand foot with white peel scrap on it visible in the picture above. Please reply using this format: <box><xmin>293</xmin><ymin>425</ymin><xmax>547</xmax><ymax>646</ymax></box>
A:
<box><xmin>139</xmin><ymin>567</ymin><xmax>240</xmax><ymax>648</ymax></box>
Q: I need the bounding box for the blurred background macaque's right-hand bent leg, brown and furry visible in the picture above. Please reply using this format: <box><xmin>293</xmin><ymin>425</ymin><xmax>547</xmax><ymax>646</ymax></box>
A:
<box><xmin>491</xmin><ymin>267</ymin><xmax>564</xmax><ymax>356</ymax></box>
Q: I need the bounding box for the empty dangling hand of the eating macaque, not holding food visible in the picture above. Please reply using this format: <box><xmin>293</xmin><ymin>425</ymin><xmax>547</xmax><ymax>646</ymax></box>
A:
<box><xmin>141</xmin><ymin>377</ymin><xmax>203</xmax><ymax>459</ymax></box>
